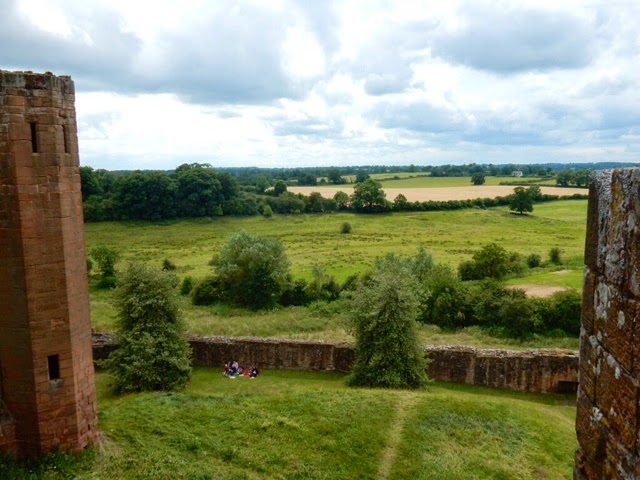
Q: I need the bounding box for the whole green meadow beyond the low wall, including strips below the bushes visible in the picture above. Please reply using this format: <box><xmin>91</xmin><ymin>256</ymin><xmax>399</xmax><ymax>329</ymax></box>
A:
<box><xmin>86</xmin><ymin>200</ymin><xmax>586</xmax><ymax>348</ymax></box>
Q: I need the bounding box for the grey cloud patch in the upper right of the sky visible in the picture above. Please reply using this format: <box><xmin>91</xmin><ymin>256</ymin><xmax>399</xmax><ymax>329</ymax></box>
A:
<box><xmin>432</xmin><ymin>3</ymin><xmax>594</xmax><ymax>74</ymax></box>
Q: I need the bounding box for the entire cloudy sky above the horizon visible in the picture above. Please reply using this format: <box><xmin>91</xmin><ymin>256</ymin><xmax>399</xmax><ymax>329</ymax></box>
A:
<box><xmin>0</xmin><ymin>0</ymin><xmax>640</xmax><ymax>170</ymax></box>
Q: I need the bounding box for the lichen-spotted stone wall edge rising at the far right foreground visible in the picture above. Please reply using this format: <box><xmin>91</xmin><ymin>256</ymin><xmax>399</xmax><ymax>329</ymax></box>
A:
<box><xmin>575</xmin><ymin>169</ymin><xmax>640</xmax><ymax>479</ymax></box>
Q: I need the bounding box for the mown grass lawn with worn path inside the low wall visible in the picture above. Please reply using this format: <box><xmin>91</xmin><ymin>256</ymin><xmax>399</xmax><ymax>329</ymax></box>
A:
<box><xmin>0</xmin><ymin>368</ymin><xmax>577</xmax><ymax>480</ymax></box>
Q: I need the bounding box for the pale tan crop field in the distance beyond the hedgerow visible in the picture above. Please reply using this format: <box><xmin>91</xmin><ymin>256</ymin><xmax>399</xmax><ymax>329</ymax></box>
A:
<box><xmin>288</xmin><ymin>185</ymin><xmax>587</xmax><ymax>202</ymax></box>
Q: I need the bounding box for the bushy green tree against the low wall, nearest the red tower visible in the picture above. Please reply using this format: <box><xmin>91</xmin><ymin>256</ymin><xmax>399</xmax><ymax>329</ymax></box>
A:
<box><xmin>103</xmin><ymin>264</ymin><xmax>191</xmax><ymax>393</ymax></box>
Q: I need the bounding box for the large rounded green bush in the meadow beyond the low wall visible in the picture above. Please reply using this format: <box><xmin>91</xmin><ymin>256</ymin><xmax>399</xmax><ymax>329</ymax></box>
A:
<box><xmin>212</xmin><ymin>230</ymin><xmax>289</xmax><ymax>308</ymax></box>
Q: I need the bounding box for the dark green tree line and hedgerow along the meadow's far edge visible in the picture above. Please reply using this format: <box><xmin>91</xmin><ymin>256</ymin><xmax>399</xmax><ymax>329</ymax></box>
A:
<box><xmin>80</xmin><ymin>164</ymin><xmax>586</xmax><ymax>222</ymax></box>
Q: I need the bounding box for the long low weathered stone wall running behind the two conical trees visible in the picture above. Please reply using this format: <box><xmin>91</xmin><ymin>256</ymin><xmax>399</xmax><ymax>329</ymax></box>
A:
<box><xmin>93</xmin><ymin>334</ymin><xmax>578</xmax><ymax>393</ymax></box>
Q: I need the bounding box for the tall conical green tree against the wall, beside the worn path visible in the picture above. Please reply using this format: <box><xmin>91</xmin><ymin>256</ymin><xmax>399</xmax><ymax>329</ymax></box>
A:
<box><xmin>348</xmin><ymin>256</ymin><xmax>428</xmax><ymax>388</ymax></box>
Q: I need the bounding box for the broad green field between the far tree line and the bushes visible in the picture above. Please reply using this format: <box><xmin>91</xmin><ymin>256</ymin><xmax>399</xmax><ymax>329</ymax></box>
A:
<box><xmin>85</xmin><ymin>200</ymin><xmax>587</xmax><ymax>280</ymax></box>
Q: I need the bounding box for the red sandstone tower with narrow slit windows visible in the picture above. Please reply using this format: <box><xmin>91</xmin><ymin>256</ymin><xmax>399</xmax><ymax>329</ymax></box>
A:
<box><xmin>0</xmin><ymin>71</ymin><xmax>97</xmax><ymax>457</ymax></box>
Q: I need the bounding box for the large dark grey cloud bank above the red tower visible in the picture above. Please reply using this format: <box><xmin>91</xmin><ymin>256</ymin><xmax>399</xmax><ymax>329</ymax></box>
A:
<box><xmin>0</xmin><ymin>0</ymin><xmax>306</xmax><ymax>103</ymax></box>
